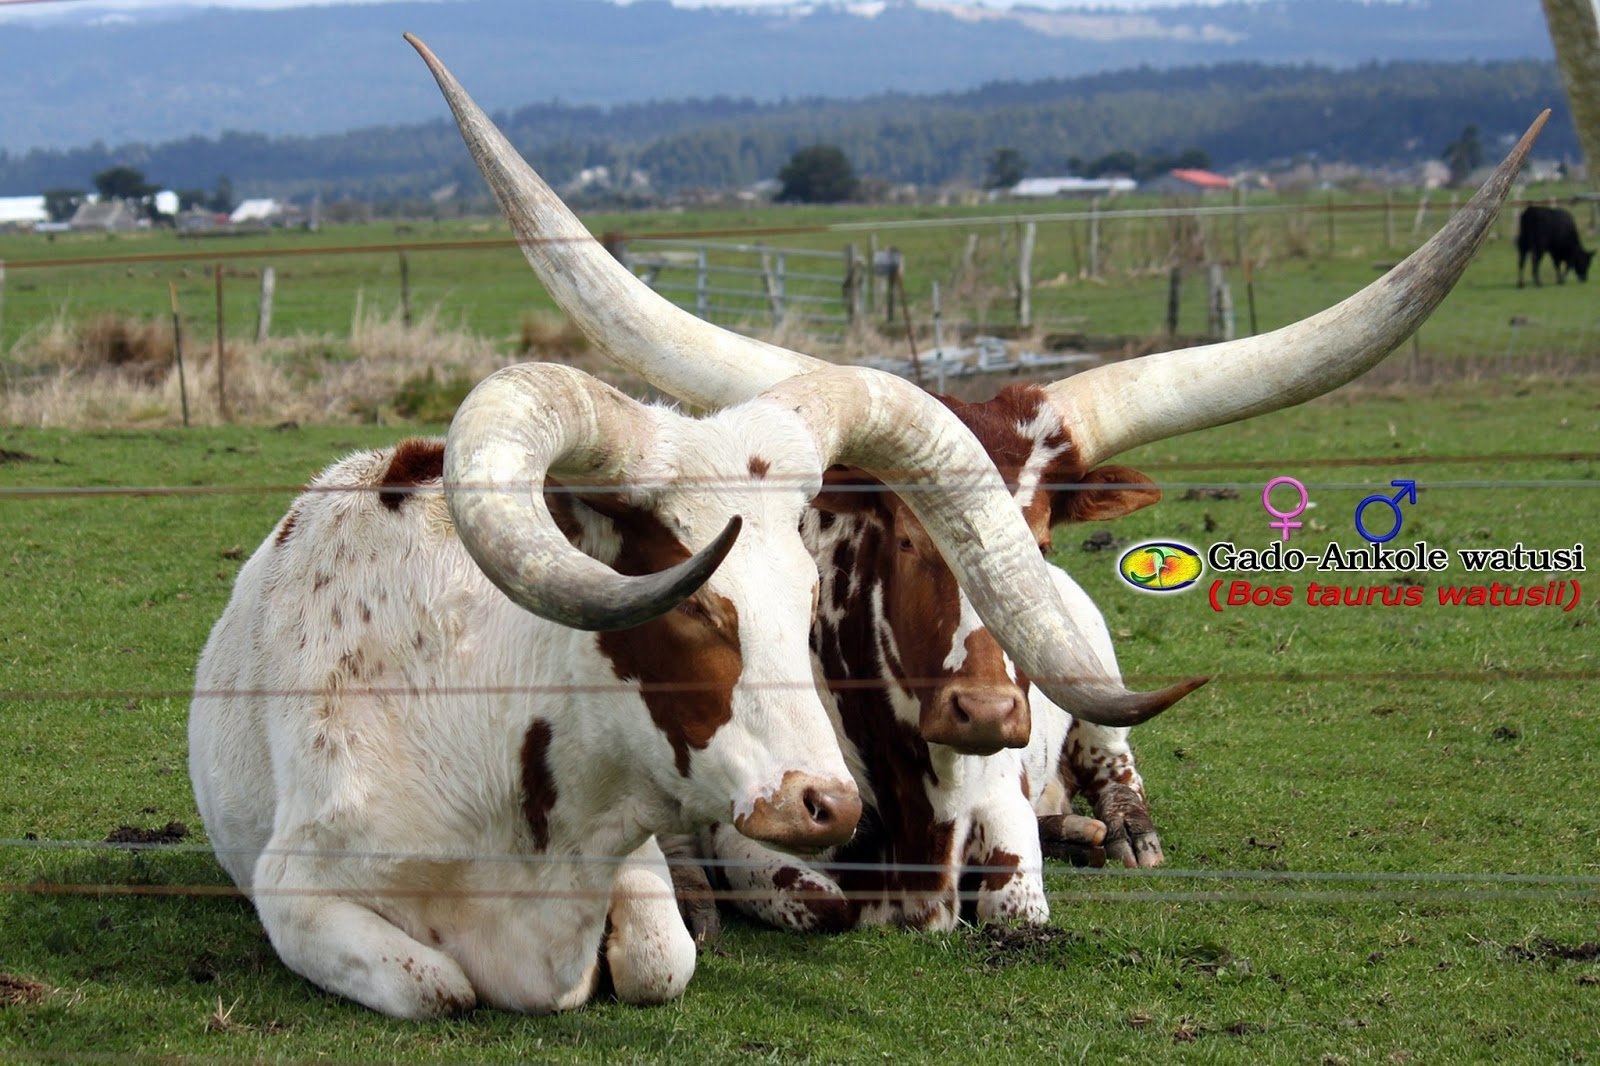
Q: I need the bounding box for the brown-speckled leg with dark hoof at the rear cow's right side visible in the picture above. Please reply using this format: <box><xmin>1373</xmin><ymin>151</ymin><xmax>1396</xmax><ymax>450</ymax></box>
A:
<box><xmin>1061</xmin><ymin>719</ymin><xmax>1166</xmax><ymax>866</ymax></box>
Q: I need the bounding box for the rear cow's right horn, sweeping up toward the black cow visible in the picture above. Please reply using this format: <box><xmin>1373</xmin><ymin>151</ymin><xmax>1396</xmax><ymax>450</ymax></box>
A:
<box><xmin>1046</xmin><ymin>110</ymin><xmax>1550</xmax><ymax>469</ymax></box>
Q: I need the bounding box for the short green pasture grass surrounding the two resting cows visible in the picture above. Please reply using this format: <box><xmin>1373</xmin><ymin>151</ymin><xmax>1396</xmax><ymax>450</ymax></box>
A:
<box><xmin>0</xmin><ymin>372</ymin><xmax>1600</xmax><ymax>1063</ymax></box>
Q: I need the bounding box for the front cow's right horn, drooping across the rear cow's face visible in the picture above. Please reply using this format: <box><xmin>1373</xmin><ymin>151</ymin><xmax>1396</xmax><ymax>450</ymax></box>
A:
<box><xmin>766</xmin><ymin>367</ymin><xmax>1206</xmax><ymax>725</ymax></box>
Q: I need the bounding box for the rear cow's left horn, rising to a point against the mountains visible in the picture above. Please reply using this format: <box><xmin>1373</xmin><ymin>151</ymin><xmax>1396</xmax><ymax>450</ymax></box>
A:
<box><xmin>405</xmin><ymin>34</ymin><xmax>830</xmax><ymax>408</ymax></box>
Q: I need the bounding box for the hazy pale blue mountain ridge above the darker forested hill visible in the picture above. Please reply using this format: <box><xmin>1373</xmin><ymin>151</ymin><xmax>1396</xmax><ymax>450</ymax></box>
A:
<box><xmin>0</xmin><ymin>0</ymin><xmax>1550</xmax><ymax>154</ymax></box>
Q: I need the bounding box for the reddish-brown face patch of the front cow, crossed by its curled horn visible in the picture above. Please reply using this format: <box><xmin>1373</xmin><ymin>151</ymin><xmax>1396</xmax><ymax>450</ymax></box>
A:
<box><xmin>572</xmin><ymin>493</ymin><xmax>744</xmax><ymax>776</ymax></box>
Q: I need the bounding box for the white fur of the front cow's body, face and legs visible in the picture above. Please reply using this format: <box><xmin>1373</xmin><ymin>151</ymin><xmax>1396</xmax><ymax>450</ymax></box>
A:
<box><xmin>190</xmin><ymin>400</ymin><xmax>848</xmax><ymax>1018</ymax></box>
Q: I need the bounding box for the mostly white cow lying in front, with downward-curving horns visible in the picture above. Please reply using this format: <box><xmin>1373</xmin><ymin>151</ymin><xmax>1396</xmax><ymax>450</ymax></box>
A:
<box><xmin>189</xmin><ymin>37</ymin><xmax>1203</xmax><ymax>1018</ymax></box>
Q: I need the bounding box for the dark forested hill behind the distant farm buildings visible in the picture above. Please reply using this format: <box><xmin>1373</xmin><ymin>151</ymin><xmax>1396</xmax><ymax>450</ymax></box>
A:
<box><xmin>0</xmin><ymin>61</ymin><xmax>1578</xmax><ymax>198</ymax></box>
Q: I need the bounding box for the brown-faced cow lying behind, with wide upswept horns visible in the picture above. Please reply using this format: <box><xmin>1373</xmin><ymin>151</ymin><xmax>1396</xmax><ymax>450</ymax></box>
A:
<box><xmin>406</xmin><ymin>33</ymin><xmax>1544</xmax><ymax>927</ymax></box>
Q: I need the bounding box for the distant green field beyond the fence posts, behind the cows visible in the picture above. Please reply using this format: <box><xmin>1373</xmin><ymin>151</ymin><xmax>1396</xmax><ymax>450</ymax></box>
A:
<box><xmin>9</xmin><ymin>178</ymin><xmax>1597</xmax><ymax>373</ymax></box>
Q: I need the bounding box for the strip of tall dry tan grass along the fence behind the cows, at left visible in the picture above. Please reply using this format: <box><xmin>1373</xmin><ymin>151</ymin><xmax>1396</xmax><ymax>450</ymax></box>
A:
<box><xmin>0</xmin><ymin>306</ymin><xmax>883</xmax><ymax>429</ymax></box>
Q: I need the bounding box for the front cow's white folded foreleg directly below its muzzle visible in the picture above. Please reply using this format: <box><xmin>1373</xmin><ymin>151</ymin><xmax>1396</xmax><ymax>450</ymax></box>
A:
<box><xmin>605</xmin><ymin>837</ymin><xmax>694</xmax><ymax>1004</ymax></box>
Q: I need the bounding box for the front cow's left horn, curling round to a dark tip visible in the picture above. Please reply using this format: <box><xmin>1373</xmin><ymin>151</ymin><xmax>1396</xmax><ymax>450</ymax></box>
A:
<box><xmin>445</xmin><ymin>363</ymin><xmax>739</xmax><ymax>629</ymax></box>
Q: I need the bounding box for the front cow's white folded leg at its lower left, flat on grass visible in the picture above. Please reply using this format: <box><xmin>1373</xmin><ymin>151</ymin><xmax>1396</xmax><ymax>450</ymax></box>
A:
<box><xmin>254</xmin><ymin>874</ymin><xmax>477</xmax><ymax>1018</ymax></box>
